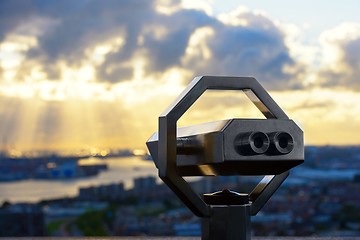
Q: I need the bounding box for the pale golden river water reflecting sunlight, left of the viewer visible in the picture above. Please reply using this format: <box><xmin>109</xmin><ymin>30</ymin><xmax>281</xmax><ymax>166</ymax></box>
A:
<box><xmin>0</xmin><ymin>157</ymin><xmax>157</xmax><ymax>204</ymax></box>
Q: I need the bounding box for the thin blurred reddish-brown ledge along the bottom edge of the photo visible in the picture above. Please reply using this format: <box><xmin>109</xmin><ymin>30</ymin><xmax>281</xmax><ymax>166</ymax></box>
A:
<box><xmin>0</xmin><ymin>236</ymin><xmax>360</xmax><ymax>240</ymax></box>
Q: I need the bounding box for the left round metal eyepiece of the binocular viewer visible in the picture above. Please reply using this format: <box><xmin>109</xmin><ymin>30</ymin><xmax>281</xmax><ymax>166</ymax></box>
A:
<box><xmin>235</xmin><ymin>132</ymin><xmax>270</xmax><ymax>155</ymax></box>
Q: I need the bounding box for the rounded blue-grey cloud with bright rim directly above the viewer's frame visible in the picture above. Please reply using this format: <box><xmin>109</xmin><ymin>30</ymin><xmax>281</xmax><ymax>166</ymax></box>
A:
<box><xmin>183</xmin><ymin>8</ymin><xmax>302</xmax><ymax>90</ymax></box>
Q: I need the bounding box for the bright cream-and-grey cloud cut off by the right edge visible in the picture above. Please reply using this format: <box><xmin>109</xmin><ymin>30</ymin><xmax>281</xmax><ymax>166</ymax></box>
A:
<box><xmin>319</xmin><ymin>23</ymin><xmax>360</xmax><ymax>91</ymax></box>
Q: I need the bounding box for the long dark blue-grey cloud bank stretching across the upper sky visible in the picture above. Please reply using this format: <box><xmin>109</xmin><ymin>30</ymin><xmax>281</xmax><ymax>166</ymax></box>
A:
<box><xmin>0</xmin><ymin>0</ymin><xmax>301</xmax><ymax>89</ymax></box>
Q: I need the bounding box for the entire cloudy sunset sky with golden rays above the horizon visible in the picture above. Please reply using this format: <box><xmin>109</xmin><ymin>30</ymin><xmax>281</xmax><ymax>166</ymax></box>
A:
<box><xmin>0</xmin><ymin>0</ymin><xmax>360</xmax><ymax>155</ymax></box>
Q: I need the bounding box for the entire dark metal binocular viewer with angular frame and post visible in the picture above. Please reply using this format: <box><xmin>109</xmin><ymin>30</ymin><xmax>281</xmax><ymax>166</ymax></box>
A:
<box><xmin>147</xmin><ymin>76</ymin><xmax>304</xmax><ymax>240</ymax></box>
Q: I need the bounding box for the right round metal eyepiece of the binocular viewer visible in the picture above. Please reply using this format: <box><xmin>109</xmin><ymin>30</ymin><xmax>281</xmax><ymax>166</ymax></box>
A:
<box><xmin>269</xmin><ymin>132</ymin><xmax>294</xmax><ymax>155</ymax></box>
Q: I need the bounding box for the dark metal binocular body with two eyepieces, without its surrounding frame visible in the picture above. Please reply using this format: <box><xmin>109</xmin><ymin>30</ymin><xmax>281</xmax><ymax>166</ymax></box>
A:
<box><xmin>148</xmin><ymin>119</ymin><xmax>303</xmax><ymax>176</ymax></box>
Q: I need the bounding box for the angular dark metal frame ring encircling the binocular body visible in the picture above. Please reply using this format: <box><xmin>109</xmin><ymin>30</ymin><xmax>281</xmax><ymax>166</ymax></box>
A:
<box><xmin>158</xmin><ymin>76</ymin><xmax>289</xmax><ymax>217</ymax></box>
